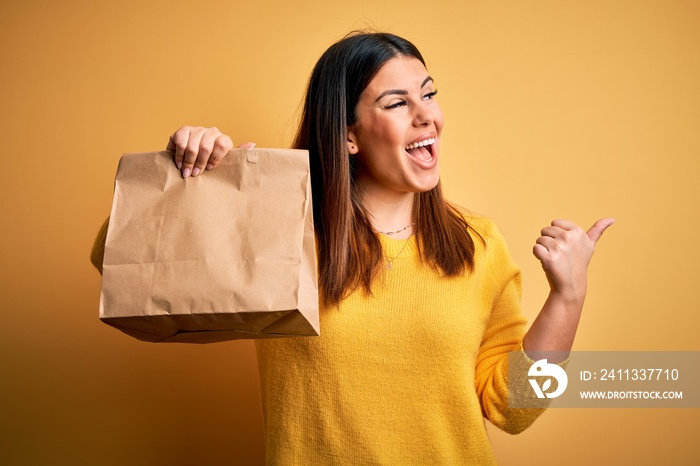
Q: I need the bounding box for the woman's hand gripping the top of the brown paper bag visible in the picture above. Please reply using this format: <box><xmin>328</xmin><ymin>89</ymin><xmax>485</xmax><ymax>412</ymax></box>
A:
<box><xmin>166</xmin><ymin>126</ymin><xmax>255</xmax><ymax>178</ymax></box>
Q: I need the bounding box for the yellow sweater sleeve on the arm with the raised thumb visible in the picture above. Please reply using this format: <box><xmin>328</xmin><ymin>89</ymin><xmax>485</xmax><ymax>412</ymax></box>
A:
<box><xmin>476</xmin><ymin>220</ymin><xmax>548</xmax><ymax>434</ymax></box>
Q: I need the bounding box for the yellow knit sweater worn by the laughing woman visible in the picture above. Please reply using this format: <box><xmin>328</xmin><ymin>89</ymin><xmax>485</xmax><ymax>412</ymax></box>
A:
<box><xmin>256</xmin><ymin>217</ymin><xmax>542</xmax><ymax>466</ymax></box>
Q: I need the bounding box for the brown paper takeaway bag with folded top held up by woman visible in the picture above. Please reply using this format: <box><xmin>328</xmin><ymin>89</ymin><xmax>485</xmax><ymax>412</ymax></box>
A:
<box><xmin>100</xmin><ymin>149</ymin><xmax>319</xmax><ymax>343</ymax></box>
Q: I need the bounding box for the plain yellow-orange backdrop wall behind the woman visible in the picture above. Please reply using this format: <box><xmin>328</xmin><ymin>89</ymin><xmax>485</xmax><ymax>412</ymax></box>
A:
<box><xmin>0</xmin><ymin>0</ymin><xmax>700</xmax><ymax>466</ymax></box>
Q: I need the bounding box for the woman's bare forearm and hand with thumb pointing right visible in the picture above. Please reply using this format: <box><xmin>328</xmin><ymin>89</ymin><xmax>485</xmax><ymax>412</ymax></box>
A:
<box><xmin>523</xmin><ymin>218</ymin><xmax>615</xmax><ymax>362</ymax></box>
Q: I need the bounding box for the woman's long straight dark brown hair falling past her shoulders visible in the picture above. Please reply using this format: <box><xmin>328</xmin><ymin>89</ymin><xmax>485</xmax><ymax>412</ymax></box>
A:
<box><xmin>293</xmin><ymin>33</ymin><xmax>474</xmax><ymax>305</ymax></box>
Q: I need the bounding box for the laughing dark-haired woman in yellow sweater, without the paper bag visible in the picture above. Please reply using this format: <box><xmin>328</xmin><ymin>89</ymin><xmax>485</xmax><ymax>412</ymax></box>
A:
<box><xmin>95</xmin><ymin>33</ymin><xmax>613</xmax><ymax>466</ymax></box>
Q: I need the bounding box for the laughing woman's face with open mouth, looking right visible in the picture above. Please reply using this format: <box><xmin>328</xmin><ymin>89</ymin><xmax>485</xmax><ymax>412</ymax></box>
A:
<box><xmin>348</xmin><ymin>55</ymin><xmax>443</xmax><ymax>195</ymax></box>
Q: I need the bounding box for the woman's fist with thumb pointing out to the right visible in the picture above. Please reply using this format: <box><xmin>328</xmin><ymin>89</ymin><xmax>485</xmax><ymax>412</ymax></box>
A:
<box><xmin>532</xmin><ymin>218</ymin><xmax>615</xmax><ymax>303</ymax></box>
